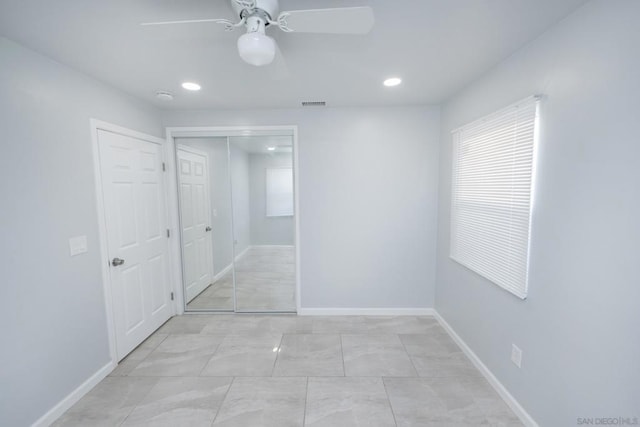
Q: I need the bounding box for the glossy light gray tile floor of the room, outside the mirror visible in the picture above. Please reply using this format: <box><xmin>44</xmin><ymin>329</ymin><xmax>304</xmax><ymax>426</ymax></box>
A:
<box><xmin>55</xmin><ymin>314</ymin><xmax>522</xmax><ymax>427</ymax></box>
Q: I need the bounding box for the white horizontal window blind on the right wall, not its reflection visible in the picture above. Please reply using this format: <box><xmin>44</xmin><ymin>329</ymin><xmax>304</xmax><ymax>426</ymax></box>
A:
<box><xmin>451</xmin><ymin>97</ymin><xmax>538</xmax><ymax>299</ymax></box>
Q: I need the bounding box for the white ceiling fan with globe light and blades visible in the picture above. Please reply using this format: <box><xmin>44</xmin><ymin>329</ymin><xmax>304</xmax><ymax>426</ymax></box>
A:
<box><xmin>140</xmin><ymin>0</ymin><xmax>374</xmax><ymax>66</ymax></box>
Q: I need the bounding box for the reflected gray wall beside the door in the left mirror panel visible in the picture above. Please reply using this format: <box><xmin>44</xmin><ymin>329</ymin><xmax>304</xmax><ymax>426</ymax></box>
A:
<box><xmin>176</xmin><ymin>137</ymin><xmax>233</xmax><ymax>274</ymax></box>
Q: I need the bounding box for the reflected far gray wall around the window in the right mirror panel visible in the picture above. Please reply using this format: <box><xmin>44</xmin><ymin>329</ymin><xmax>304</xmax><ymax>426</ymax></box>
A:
<box><xmin>249</xmin><ymin>153</ymin><xmax>295</xmax><ymax>245</ymax></box>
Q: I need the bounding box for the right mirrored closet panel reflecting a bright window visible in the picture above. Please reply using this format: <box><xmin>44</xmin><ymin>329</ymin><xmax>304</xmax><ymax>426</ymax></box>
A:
<box><xmin>229</xmin><ymin>135</ymin><xmax>296</xmax><ymax>312</ymax></box>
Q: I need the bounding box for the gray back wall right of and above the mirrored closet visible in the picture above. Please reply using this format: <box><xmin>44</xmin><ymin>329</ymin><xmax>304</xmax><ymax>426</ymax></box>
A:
<box><xmin>164</xmin><ymin>107</ymin><xmax>440</xmax><ymax>308</ymax></box>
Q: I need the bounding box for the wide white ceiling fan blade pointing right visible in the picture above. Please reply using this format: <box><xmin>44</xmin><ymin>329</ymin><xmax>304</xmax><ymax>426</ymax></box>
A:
<box><xmin>278</xmin><ymin>6</ymin><xmax>375</xmax><ymax>34</ymax></box>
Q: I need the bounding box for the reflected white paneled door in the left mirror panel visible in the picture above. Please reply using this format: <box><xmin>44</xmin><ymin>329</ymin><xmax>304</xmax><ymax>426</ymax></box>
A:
<box><xmin>177</xmin><ymin>145</ymin><xmax>213</xmax><ymax>303</ymax></box>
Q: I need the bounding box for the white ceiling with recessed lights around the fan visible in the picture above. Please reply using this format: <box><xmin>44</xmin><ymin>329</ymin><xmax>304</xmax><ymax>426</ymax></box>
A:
<box><xmin>0</xmin><ymin>0</ymin><xmax>585</xmax><ymax>109</ymax></box>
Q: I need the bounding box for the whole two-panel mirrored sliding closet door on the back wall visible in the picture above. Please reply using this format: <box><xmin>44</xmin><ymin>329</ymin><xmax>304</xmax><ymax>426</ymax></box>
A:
<box><xmin>175</xmin><ymin>132</ymin><xmax>296</xmax><ymax>312</ymax></box>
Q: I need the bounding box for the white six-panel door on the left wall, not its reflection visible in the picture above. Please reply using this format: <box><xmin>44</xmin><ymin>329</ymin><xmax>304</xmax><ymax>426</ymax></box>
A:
<box><xmin>98</xmin><ymin>130</ymin><xmax>173</xmax><ymax>360</ymax></box>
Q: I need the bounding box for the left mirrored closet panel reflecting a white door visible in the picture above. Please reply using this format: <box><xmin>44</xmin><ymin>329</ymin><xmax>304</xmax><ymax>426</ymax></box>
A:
<box><xmin>175</xmin><ymin>137</ymin><xmax>234</xmax><ymax>311</ymax></box>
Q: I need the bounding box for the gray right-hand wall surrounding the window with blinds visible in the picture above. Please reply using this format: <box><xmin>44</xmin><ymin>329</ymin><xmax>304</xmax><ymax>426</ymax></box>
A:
<box><xmin>436</xmin><ymin>0</ymin><xmax>640</xmax><ymax>426</ymax></box>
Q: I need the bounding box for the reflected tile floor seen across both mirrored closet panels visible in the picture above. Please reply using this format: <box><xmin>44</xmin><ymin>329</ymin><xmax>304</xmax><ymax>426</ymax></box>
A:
<box><xmin>187</xmin><ymin>246</ymin><xmax>296</xmax><ymax>312</ymax></box>
